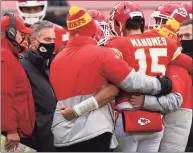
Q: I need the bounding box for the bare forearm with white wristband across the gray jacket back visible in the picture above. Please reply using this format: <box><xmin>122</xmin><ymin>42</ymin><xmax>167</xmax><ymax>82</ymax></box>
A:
<box><xmin>73</xmin><ymin>84</ymin><xmax>119</xmax><ymax>116</ymax></box>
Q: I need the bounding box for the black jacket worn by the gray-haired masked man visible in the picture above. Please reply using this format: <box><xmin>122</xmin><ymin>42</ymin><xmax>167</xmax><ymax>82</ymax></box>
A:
<box><xmin>20</xmin><ymin>51</ymin><xmax>57</xmax><ymax>151</ymax></box>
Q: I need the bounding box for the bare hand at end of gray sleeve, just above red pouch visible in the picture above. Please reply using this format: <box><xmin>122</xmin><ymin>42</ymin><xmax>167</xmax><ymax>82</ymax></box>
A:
<box><xmin>129</xmin><ymin>95</ymin><xmax>145</xmax><ymax>108</ymax></box>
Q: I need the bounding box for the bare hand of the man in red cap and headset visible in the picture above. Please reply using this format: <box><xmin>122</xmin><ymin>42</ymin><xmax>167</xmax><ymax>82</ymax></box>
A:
<box><xmin>5</xmin><ymin>133</ymin><xmax>20</xmax><ymax>152</ymax></box>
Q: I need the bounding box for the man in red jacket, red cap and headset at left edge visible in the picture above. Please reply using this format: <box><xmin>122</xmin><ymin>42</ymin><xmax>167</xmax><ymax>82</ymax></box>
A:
<box><xmin>1</xmin><ymin>12</ymin><xmax>35</xmax><ymax>151</ymax></box>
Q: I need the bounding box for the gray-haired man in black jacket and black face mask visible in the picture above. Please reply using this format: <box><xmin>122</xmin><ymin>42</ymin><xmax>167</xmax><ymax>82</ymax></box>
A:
<box><xmin>20</xmin><ymin>20</ymin><xmax>56</xmax><ymax>152</ymax></box>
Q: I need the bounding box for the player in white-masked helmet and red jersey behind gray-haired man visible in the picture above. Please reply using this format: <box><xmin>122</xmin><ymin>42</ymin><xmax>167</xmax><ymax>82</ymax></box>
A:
<box><xmin>16</xmin><ymin>0</ymin><xmax>68</xmax><ymax>54</ymax></box>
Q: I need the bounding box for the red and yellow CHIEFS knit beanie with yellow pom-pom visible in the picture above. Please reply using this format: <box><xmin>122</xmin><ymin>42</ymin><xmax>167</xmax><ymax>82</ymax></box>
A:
<box><xmin>67</xmin><ymin>6</ymin><xmax>97</xmax><ymax>37</ymax></box>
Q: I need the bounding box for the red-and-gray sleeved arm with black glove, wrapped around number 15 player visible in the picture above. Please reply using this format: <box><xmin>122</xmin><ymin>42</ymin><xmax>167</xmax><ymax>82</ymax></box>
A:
<box><xmin>101</xmin><ymin>48</ymin><xmax>171</xmax><ymax>95</ymax></box>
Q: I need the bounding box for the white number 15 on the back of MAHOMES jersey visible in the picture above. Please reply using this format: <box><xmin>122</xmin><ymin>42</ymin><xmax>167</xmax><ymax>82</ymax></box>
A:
<box><xmin>135</xmin><ymin>48</ymin><xmax>167</xmax><ymax>75</ymax></box>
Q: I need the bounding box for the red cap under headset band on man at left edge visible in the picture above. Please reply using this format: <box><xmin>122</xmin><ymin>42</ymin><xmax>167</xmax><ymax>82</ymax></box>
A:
<box><xmin>1</xmin><ymin>15</ymin><xmax>33</xmax><ymax>34</ymax></box>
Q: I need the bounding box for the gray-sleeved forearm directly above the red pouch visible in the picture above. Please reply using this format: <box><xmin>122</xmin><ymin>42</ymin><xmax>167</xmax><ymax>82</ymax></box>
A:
<box><xmin>143</xmin><ymin>93</ymin><xmax>183</xmax><ymax>114</ymax></box>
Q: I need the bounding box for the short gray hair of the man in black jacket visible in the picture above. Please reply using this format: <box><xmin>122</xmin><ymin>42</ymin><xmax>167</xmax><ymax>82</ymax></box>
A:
<box><xmin>29</xmin><ymin>20</ymin><xmax>54</xmax><ymax>37</ymax></box>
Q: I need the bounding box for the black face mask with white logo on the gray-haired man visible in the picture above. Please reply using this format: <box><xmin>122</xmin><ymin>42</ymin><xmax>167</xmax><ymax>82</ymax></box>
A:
<box><xmin>38</xmin><ymin>43</ymin><xmax>55</xmax><ymax>60</ymax></box>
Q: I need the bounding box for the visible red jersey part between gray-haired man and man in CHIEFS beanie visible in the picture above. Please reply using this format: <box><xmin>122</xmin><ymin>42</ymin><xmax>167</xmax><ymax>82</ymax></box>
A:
<box><xmin>54</xmin><ymin>25</ymin><xmax>69</xmax><ymax>54</ymax></box>
